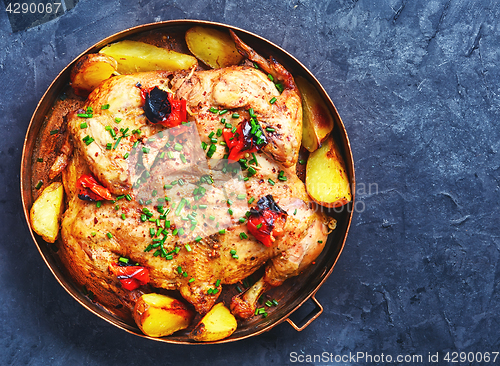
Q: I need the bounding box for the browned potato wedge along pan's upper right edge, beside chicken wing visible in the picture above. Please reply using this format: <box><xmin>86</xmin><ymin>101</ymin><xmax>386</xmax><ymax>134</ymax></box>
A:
<box><xmin>295</xmin><ymin>76</ymin><xmax>333</xmax><ymax>152</ymax></box>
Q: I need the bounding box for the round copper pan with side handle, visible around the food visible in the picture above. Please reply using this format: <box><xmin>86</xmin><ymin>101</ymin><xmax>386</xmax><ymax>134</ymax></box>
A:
<box><xmin>20</xmin><ymin>20</ymin><xmax>355</xmax><ymax>344</ymax></box>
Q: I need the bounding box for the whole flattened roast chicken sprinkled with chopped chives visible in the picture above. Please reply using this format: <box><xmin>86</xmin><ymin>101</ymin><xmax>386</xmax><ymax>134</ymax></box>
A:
<box><xmin>60</xmin><ymin>33</ymin><xmax>330</xmax><ymax>319</ymax></box>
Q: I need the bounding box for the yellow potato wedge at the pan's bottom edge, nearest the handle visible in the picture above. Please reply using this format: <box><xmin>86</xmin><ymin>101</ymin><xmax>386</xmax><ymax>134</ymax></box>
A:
<box><xmin>189</xmin><ymin>302</ymin><xmax>238</xmax><ymax>342</ymax></box>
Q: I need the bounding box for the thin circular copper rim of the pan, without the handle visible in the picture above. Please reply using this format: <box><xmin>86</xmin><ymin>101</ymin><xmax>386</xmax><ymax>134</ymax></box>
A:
<box><xmin>20</xmin><ymin>19</ymin><xmax>356</xmax><ymax>345</ymax></box>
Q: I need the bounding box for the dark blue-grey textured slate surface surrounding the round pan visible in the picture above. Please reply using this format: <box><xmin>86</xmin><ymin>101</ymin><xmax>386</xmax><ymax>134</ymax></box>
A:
<box><xmin>0</xmin><ymin>0</ymin><xmax>500</xmax><ymax>365</ymax></box>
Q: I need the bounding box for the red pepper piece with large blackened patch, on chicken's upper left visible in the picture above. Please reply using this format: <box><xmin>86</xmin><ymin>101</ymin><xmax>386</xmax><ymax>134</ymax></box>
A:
<box><xmin>141</xmin><ymin>86</ymin><xmax>187</xmax><ymax>127</ymax></box>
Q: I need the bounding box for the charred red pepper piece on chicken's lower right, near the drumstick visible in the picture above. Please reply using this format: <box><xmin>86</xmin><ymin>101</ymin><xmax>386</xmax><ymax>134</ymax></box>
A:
<box><xmin>247</xmin><ymin>194</ymin><xmax>288</xmax><ymax>247</ymax></box>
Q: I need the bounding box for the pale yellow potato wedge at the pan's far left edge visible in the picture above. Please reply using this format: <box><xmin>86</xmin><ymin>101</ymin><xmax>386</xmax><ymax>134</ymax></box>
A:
<box><xmin>30</xmin><ymin>182</ymin><xmax>64</xmax><ymax>243</ymax></box>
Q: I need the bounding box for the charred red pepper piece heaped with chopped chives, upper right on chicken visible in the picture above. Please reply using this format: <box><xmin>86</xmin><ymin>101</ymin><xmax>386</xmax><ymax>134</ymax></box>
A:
<box><xmin>222</xmin><ymin>120</ymin><xmax>267</xmax><ymax>161</ymax></box>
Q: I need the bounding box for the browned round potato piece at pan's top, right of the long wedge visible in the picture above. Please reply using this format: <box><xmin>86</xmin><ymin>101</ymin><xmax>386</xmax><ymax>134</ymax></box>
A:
<box><xmin>186</xmin><ymin>26</ymin><xmax>243</xmax><ymax>69</ymax></box>
